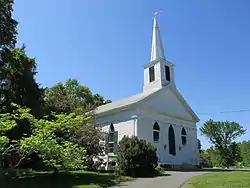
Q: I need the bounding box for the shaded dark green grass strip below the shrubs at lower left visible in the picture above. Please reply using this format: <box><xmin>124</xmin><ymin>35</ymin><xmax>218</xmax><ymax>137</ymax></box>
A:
<box><xmin>0</xmin><ymin>171</ymin><xmax>133</xmax><ymax>188</ymax></box>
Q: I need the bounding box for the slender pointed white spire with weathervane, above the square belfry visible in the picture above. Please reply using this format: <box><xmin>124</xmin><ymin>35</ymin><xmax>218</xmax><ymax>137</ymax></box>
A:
<box><xmin>150</xmin><ymin>12</ymin><xmax>165</xmax><ymax>61</ymax></box>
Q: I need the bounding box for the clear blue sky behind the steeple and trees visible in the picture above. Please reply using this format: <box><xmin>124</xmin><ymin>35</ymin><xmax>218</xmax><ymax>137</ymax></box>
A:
<box><xmin>14</xmin><ymin>0</ymin><xmax>250</xmax><ymax>147</ymax></box>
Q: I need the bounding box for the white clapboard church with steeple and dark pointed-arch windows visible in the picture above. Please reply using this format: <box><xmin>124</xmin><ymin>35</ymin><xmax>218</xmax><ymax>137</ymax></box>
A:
<box><xmin>95</xmin><ymin>15</ymin><xmax>199</xmax><ymax>169</ymax></box>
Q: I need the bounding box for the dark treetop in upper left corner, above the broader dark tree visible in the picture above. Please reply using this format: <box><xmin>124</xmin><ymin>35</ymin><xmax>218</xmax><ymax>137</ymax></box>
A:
<box><xmin>0</xmin><ymin>0</ymin><xmax>17</xmax><ymax>48</ymax></box>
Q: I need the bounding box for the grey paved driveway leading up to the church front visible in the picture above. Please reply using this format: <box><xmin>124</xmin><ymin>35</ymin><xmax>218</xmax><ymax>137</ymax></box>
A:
<box><xmin>110</xmin><ymin>171</ymin><xmax>206</xmax><ymax>188</ymax></box>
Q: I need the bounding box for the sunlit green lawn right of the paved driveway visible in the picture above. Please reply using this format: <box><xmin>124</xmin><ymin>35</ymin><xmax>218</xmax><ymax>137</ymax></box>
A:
<box><xmin>183</xmin><ymin>172</ymin><xmax>250</xmax><ymax>188</ymax></box>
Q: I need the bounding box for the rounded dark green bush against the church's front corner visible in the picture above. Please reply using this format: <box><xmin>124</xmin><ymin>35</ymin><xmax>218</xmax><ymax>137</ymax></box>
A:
<box><xmin>117</xmin><ymin>136</ymin><xmax>158</xmax><ymax>176</ymax></box>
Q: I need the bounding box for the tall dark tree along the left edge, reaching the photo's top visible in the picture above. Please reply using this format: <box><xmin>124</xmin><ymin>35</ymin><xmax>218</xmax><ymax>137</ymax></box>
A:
<box><xmin>0</xmin><ymin>0</ymin><xmax>43</xmax><ymax>116</ymax></box>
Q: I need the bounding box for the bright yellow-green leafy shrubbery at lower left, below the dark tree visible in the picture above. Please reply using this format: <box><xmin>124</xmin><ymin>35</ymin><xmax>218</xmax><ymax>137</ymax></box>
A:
<box><xmin>0</xmin><ymin>105</ymin><xmax>86</xmax><ymax>169</ymax></box>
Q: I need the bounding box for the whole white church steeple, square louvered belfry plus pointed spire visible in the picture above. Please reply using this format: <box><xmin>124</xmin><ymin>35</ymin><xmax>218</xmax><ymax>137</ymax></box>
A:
<box><xmin>143</xmin><ymin>12</ymin><xmax>174</xmax><ymax>91</ymax></box>
